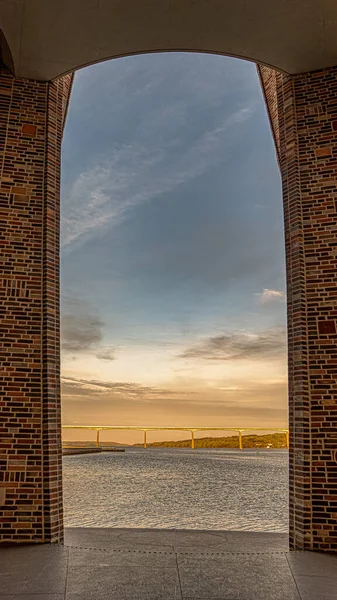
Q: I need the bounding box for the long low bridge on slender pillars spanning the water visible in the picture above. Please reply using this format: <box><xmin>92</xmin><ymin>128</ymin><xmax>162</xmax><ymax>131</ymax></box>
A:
<box><xmin>62</xmin><ymin>425</ymin><xmax>289</xmax><ymax>450</ymax></box>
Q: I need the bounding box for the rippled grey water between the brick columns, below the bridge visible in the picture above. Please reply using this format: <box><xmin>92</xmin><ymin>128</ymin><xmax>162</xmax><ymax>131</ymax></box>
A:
<box><xmin>63</xmin><ymin>448</ymin><xmax>288</xmax><ymax>532</ymax></box>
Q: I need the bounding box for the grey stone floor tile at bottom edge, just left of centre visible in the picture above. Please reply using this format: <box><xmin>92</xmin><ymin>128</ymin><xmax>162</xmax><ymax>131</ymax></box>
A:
<box><xmin>66</xmin><ymin>565</ymin><xmax>182</xmax><ymax>600</ymax></box>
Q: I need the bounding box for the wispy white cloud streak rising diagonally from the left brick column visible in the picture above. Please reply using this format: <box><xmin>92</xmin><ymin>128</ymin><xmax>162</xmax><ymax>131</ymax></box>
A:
<box><xmin>61</xmin><ymin>105</ymin><xmax>254</xmax><ymax>251</ymax></box>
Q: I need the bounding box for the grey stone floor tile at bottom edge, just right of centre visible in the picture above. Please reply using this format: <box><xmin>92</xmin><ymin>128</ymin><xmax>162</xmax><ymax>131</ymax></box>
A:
<box><xmin>178</xmin><ymin>554</ymin><xmax>300</xmax><ymax>600</ymax></box>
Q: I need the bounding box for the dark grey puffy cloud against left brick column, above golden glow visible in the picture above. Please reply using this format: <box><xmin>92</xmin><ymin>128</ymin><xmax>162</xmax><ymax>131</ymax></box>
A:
<box><xmin>61</xmin><ymin>299</ymin><xmax>115</xmax><ymax>360</ymax></box>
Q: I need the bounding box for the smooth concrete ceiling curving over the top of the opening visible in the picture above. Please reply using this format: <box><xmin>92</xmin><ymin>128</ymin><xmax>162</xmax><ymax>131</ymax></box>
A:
<box><xmin>0</xmin><ymin>0</ymin><xmax>337</xmax><ymax>80</ymax></box>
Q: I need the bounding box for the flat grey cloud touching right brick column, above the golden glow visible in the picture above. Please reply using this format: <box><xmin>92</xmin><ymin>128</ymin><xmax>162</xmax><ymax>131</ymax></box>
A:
<box><xmin>180</xmin><ymin>328</ymin><xmax>286</xmax><ymax>361</ymax></box>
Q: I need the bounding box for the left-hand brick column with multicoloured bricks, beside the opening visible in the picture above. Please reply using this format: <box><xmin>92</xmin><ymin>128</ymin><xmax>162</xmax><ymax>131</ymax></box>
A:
<box><xmin>0</xmin><ymin>69</ymin><xmax>72</xmax><ymax>542</ymax></box>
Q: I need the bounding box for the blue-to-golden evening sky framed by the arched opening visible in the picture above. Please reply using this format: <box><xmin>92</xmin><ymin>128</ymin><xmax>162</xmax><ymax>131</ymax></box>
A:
<box><xmin>61</xmin><ymin>53</ymin><xmax>287</xmax><ymax>442</ymax></box>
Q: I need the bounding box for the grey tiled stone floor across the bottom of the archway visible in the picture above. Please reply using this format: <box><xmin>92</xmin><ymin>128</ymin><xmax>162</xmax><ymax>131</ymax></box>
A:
<box><xmin>0</xmin><ymin>528</ymin><xmax>337</xmax><ymax>600</ymax></box>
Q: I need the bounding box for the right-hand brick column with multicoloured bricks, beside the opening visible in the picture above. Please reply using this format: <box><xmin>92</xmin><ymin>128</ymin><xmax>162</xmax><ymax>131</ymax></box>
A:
<box><xmin>259</xmin><ymin>67</ymin><xmax>337</xmax><ymax>551</ymax></box>
